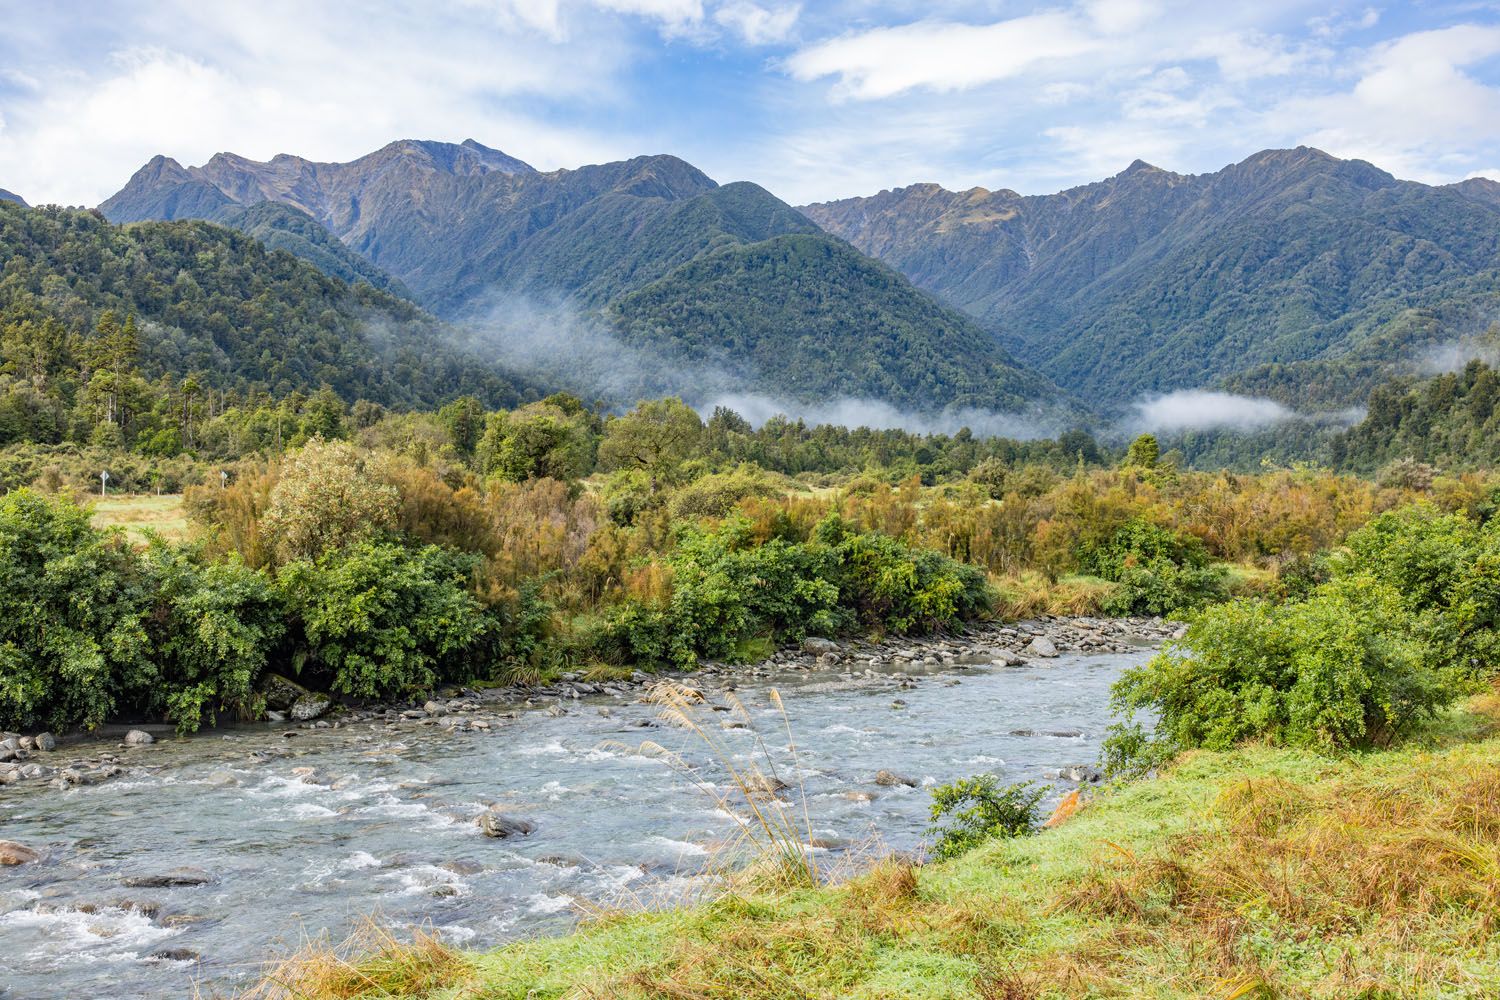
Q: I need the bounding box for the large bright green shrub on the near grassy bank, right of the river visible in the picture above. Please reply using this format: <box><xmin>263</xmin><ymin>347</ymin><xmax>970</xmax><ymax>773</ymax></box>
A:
<box><xmin>1106</xmin><ymin>577</ymin><xmax>1461</xmax><ymax>774</ymax></box>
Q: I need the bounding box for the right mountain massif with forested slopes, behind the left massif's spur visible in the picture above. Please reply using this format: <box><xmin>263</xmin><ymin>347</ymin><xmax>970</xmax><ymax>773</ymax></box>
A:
<box><xmin>803</xmin><ymin>147</ymin><xmax>1500</xmax><ymax>406</ymax></box>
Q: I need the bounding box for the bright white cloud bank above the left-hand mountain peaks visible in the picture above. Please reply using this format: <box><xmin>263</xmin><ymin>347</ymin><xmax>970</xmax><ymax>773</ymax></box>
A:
<box><xmin>0</xmin><ymin>0</ymin><xmax>636</xmax><ymax>204</ymax></box>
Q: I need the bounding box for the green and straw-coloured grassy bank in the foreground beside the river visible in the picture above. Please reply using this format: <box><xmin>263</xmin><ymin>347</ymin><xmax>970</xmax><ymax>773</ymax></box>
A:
<box><xmin>249</xmin><ymin>696</ymin><xmax>1500</xmax><ymax>1000</ymax></box>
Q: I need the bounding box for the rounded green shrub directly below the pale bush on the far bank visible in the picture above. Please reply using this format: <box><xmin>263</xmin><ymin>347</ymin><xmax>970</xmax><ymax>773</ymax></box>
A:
<box><xmin>276</xmin><ymin>541</ymin><xmax>497</xmax><ymax>699</ymax></box>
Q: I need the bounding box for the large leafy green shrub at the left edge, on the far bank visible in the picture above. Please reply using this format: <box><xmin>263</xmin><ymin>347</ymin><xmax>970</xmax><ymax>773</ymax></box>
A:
<box><xmin>0</xmin><ymin>489</ymin><xmax>156</xmax><ymax>729</ymax></box>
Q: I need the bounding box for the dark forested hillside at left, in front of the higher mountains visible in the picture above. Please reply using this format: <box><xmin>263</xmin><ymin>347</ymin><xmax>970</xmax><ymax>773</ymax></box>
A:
<box><xmin>0</xmin><ymin>202</ymin><xmax>536</xmax><ymax>406</ymax></box>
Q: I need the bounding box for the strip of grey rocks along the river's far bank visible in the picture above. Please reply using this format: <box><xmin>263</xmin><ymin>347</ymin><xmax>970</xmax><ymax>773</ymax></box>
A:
<box><xmin>0</xmin><ymin>618</ymin><xmax>1178</xmax><ymax>793</ymax></box>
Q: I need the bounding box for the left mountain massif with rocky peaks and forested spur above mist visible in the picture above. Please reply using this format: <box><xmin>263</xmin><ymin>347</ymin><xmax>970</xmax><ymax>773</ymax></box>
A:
<box><xmin>101</xmin><ymin>139</ymin><xmax>1062</xmax><ymax>411</ymax></box>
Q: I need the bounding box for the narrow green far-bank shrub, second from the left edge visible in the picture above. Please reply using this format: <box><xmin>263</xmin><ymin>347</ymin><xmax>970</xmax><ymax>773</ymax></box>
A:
<box><xmin>146</xmin><ymin>543</ymin><xmax>285</xmax><ymax>732</ymax></box>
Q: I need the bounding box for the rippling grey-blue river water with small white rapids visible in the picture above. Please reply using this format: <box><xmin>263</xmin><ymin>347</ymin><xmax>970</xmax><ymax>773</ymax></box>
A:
<box><xmin>0</xmin><ymin>651</ymin><xmax>1149</xmax><ymax>1000</ymax></box>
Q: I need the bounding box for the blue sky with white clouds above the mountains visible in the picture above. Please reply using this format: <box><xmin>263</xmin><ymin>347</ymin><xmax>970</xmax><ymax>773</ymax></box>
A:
<box><xmin>0</xmin><ymin>0</ymin><xmax>1500</xmax><ymax>205</ymax></box>
